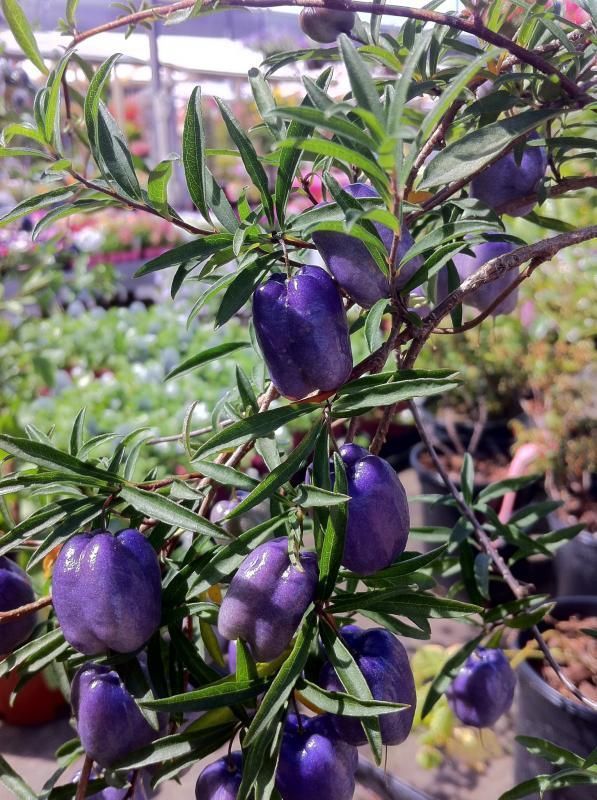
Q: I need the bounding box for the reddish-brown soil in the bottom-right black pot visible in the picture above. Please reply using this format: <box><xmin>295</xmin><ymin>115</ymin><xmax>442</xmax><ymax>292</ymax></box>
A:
<box><xmin>539</xmin><ymin>617</ymin><xmax>597</xmax><ymax>703</ymax></box>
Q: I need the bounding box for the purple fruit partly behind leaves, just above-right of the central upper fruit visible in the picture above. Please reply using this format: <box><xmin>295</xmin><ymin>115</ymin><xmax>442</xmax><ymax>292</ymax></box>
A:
<box><xmin>312</xmin><ymin>183</ymin><xmax>423</xmax><ymax>308</ymax></box>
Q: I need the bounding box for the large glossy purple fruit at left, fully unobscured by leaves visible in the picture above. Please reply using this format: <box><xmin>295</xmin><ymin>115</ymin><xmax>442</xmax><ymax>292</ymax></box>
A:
<box><xmin>52</xmin><ymin>529</ymin><xmax>162</xmax><ymax>655</ymax></box>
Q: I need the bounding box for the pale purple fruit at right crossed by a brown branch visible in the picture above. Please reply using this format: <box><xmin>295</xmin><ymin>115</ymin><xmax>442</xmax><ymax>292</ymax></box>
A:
<box><xmin>437</xmin><ymin>239</ymin><xmax>518</xmax><ymax>317</ymax></box>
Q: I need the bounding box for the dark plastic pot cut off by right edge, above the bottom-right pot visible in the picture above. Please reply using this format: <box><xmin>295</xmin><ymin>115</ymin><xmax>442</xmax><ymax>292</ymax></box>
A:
<box><xmin>549</xmin><ymin>514</ymin><xmax>597</xmax><ymax>596</ymax></box>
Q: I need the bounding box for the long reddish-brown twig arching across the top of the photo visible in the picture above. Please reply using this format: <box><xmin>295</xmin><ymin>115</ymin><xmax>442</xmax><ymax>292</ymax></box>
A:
<box><xmin>72</xmin><ymin>0</ymin><xmax>587</xmax><ymax>102</ymax></box>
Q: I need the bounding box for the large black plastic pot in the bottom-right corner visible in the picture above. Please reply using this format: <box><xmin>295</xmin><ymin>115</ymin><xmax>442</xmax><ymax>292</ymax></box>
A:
<box><xmin>514</xmin><ymin>596</ymin><xmax>597</xmax><ymax>800</ymax></box>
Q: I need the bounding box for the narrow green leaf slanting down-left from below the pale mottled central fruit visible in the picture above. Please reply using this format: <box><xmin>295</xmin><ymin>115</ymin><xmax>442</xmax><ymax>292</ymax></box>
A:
<box><xmin>243</xmin><ymin>611</ymin><xmax>317</xmax><ymax>747</ymax></box>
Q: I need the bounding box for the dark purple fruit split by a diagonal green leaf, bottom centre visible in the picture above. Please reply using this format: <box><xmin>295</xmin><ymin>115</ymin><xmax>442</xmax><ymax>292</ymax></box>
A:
<box><xmin>320</xmin><ymin>625</ymin><xmax>417</xmax><ymax>746</ymax></box>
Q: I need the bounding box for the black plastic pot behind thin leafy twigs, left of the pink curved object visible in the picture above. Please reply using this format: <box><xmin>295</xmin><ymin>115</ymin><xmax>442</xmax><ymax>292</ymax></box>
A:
<box><xmin>410</xmin><ymin>443</ymin><xmax>555</xmax><ymax>603</ymax></box>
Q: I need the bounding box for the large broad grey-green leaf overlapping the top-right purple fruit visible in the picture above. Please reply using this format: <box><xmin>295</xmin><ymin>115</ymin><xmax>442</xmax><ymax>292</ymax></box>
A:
<box><xmin>418</xmin><ymin>110</ymin><xmax>558</xmax><ymax>189</ymax></box>
